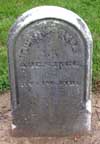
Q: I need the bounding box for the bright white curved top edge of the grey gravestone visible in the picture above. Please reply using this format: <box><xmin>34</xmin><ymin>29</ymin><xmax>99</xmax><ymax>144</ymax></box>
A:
<box><xmin>9</xmin><ymin>6</ymin><xmax>92</xmax><ymax>45</ymax></box>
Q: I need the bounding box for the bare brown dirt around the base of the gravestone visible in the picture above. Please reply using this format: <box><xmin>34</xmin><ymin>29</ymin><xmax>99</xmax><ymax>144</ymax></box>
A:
<box><xmin>0</xmin><ymin>92</ymin><xmax>100</xmax><ymax>144</ymax></box>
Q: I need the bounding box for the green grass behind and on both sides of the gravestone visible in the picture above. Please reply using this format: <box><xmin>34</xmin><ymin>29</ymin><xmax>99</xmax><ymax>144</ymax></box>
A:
<box><xmin>0</xmin><ymin>0</ymin><xmax>100</xmax><ymax>91</ymax></box>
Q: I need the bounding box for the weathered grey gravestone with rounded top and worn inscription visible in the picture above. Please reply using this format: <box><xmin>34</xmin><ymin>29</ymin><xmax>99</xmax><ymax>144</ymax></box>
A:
<box><xmin>8</xmin><ymin>6</ymin><xmax>92</xmax><ymax>136</ymax></box>
